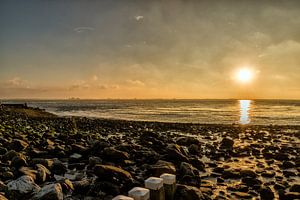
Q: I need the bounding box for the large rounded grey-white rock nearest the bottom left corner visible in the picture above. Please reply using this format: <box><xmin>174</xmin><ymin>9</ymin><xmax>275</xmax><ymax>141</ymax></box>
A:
<box><xmin>7</xmin><ymin>175</ymin><xmax>40</xmax><ymax>199</ymax></box>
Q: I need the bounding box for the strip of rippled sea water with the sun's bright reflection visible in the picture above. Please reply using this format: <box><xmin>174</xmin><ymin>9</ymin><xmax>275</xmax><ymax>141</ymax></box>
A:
<box><xmin>2</xmin><ymin>100</ymin><xmax>300</xmax><ymax>125</ymax></box>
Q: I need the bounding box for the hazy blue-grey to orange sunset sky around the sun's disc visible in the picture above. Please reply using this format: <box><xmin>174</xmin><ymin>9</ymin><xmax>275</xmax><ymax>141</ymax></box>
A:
<box><xmin>0</xmin><ymin>0</ymin><xmax>300</xmax><ymax>99</ymax></box>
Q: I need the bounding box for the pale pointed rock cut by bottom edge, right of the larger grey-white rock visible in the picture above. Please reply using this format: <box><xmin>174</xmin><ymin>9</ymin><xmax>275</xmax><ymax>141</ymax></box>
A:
<box><xmin>32</xmin><ymin>183</ymin><xmax>64</xmax><ymax>200</ymax></box>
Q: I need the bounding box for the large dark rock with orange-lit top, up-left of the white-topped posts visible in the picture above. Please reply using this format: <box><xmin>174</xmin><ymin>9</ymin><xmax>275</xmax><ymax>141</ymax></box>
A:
<box><xmin>94</xmin><ymin>165</ymin><xmax>132</xmax><ymax>181</ymax></box>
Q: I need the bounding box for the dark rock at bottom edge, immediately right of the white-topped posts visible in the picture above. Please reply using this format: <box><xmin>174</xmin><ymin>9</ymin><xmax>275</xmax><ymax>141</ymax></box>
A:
<box><xmin>174</xmin><ymin>184</ymin><xmax>205</xmax><ymax>200</ymax></box>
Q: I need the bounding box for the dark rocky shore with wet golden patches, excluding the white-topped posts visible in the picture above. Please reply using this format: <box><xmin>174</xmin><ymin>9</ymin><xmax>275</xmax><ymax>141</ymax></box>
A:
<box><xmin>0</xmin><ymin>106</ymin><xmax>300</xmax><ymax>200</ymax></box>
